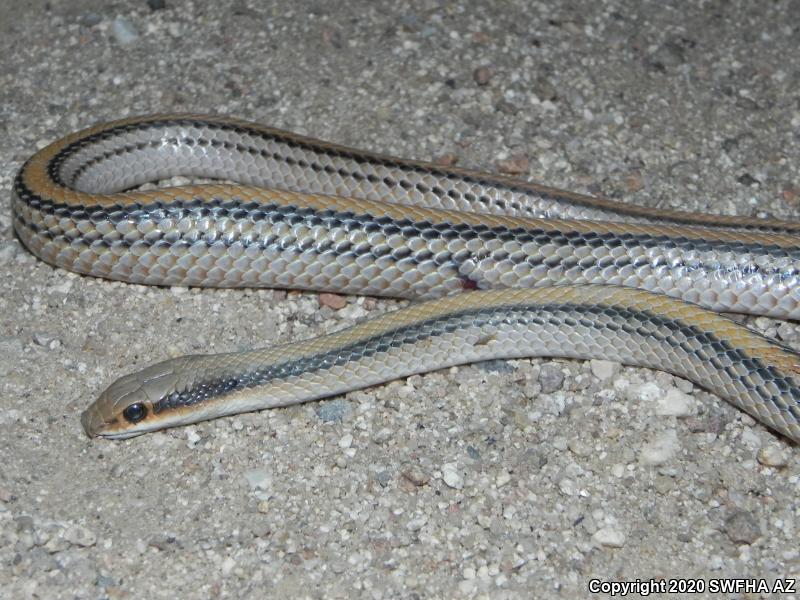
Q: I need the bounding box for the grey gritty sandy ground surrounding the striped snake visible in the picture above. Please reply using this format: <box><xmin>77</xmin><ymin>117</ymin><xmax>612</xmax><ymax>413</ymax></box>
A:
<box><xmin>0</xmin><ymin>0</ymin><xmax>800</xmax><ymax>599</ymax></box>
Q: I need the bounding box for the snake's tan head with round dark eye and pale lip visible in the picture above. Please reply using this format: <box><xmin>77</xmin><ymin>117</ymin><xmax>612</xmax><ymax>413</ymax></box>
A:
<box><xmin>81</xmin><ymin>356</ymin><xmax>196</xmax><ymax>439</ymax></box>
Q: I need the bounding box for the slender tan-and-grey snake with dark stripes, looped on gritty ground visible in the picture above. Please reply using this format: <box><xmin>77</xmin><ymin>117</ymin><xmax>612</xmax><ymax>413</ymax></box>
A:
<box><xmin>11</xmin><ymin>114</ymin><xmax>800</xmax><ymax>442</ymax></box>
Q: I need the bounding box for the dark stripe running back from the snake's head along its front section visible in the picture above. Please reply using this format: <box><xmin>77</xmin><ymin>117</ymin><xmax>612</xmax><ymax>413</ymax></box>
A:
<box><xmin>153</xmin><ymin>303</ymin><xmax>800</xmax><ymax>419</ymax></box>
